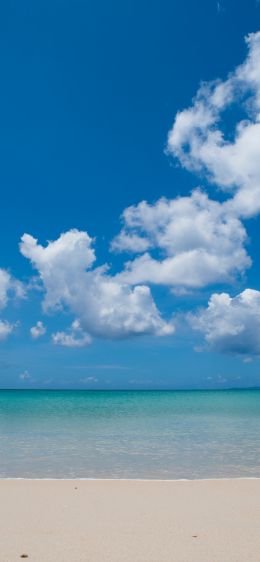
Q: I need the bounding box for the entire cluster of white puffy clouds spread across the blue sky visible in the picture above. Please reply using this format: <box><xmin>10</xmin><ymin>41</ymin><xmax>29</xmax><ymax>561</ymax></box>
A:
<box><xmin>3</xmin><ymin>32</ymin><xmax>260</xmax><ymax>355</ymax></box>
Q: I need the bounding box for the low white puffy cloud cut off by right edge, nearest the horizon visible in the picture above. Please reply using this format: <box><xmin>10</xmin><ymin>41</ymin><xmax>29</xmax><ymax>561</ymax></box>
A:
<box><xmin>188</xmin><ymin>289</ymin><xmax>260</xmax><ymax>356</ymax></box>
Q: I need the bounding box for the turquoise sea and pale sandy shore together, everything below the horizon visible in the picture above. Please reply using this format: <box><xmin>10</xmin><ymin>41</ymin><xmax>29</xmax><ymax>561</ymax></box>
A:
<box><xmin>0</xmin><ymin>391</ymin><xmax>260</xmax><ymax>562</ymax></box>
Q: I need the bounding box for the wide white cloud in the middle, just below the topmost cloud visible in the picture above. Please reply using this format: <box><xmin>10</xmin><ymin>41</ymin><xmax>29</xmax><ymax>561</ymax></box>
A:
<box><xmin>112</xmin><ymin>190</ymin><xmax>251</xmax><ymax>287</ymax></box>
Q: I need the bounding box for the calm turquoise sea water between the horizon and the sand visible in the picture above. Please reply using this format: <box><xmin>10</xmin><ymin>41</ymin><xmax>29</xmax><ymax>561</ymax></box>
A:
<box><xmin>0</xmin><ymin>390</ymin><xmax>260</xmax><ymax>479</ymax></box>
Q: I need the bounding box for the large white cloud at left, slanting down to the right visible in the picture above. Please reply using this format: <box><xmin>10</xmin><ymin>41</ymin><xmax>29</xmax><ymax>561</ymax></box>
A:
<box><xmin>20</xmin><ymin>230</ymin><xmax>174</xmax><ymax>343</ymax></box>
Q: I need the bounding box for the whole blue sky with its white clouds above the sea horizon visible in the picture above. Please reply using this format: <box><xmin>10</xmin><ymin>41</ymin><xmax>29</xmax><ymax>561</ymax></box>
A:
<box><xmin>0</xmin><ymin>0</ymin><xmax>260</xmax><ymax>390</ymax></box>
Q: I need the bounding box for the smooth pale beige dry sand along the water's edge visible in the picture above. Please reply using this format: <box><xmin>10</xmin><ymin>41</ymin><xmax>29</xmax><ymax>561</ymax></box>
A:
<box><xmin>0</xmin><ymin>480</ymin><xmax>260</xmax><ymax>562</ymax></box>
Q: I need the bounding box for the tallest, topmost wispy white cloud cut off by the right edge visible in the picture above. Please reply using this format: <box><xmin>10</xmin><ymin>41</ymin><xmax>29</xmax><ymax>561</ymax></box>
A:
<box><xmin>168</xmin><ymin>32</ymin><xmax>260</xmax><ymax>217</ymax></box>
